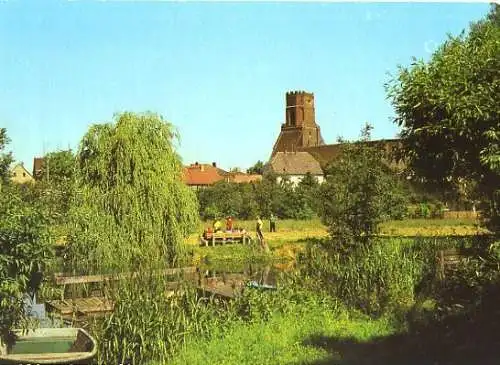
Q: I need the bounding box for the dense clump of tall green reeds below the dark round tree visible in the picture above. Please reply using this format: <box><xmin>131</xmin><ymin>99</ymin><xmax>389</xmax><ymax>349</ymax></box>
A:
<box><xmin>300</xmin><ymin>240</ymin><xmax>423</xmax><ymax>315</ymax></box>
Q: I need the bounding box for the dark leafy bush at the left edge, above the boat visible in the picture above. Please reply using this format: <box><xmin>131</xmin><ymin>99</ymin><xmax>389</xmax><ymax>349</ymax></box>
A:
<box><xmin>0</xmin><ymin>186</ymin><xmax>53</xmax><ymax>344</ymax></box>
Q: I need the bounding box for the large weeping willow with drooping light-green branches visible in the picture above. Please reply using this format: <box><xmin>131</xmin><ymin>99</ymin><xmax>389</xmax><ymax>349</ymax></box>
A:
<box><xmin>67</xmin><ymin>112</ymin><xmax>198</xmax><ymax>273</ymax></box>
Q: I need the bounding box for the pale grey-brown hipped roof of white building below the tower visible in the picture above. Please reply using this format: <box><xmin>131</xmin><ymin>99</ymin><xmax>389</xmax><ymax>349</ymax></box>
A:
<box><xmin>268</xmin><ymin>152</ymin><xmax>323</xmax><ymax>175</ymax></box>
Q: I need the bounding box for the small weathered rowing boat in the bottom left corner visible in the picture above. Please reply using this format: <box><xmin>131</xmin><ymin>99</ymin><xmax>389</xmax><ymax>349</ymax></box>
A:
<box><xmin>0</xmin><ymin>328</ymin><xmax>97</xmax><ymax>365</ymax></box>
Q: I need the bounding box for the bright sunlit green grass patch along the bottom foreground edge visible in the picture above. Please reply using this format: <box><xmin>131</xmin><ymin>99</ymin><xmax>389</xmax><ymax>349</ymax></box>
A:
<box><xmin>160</xmin><ymin>308</ymin><xmax>394</xmax><ymax>365</ymax></box>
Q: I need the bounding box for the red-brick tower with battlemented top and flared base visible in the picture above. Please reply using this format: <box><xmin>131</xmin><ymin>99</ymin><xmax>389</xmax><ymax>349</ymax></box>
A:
<box><xmin>272</xmin><ymin>91</ymin><xmax>324</xmax><ymax>156</ymax></box>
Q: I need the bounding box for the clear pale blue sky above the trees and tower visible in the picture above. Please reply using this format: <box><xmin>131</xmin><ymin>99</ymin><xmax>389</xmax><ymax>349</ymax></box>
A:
<box><xmin>0</xmin><ymin>1</ymin><xmax>489</xmax><ymax>169</ymax></box>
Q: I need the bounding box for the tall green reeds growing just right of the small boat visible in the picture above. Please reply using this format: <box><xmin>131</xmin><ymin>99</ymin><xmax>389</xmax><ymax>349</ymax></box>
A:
<box><xmin>93</xmin><ymin>280</ymin><xmax>234</xmax><ymax>364</ymax></box>
